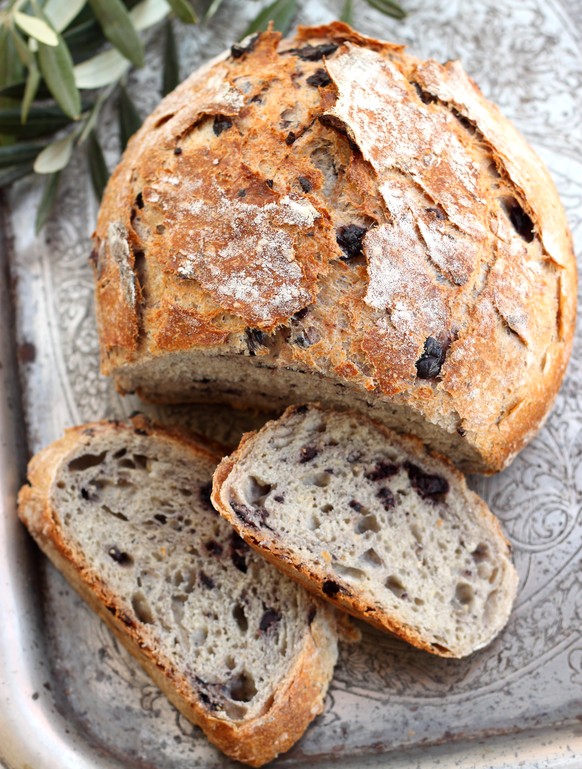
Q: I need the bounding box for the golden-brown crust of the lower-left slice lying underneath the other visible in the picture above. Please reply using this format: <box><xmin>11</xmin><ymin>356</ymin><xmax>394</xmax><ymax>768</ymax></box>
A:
<box><xmin>18</xmin><ymin>417</ymin><xmax>337</xmax><ymax>766</ymax></box>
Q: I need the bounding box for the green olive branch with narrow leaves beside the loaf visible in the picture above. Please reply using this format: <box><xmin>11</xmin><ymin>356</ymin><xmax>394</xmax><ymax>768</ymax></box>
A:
<box><xmin>0</xmin><ymin>0</ymin><xmax>405</xmax><ymax>232</ymax></box>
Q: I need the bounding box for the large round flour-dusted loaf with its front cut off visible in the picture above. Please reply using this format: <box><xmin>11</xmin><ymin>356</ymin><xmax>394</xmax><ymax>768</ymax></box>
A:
<box><xmin>93</xmin><ymin>23</ymin><xmax>576</xmax><ymax>472</ymax></box>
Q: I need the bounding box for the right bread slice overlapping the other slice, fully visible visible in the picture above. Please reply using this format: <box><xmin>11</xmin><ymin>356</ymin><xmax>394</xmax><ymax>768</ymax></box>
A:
<box><xmin>212</xmin><ymin>405</ymin><xmax>517</xmax><ymax>657</ymax></box>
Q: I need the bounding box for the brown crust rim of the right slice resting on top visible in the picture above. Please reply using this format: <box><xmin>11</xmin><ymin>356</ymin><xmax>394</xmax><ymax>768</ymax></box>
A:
<box><xmin>211</xmin><ymin>404</ymin><xmax>518</xmax><ymax>657</ymax></box>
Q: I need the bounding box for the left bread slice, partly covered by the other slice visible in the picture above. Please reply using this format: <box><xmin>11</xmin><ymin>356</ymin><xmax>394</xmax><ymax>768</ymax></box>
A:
<box><xmin>19</xmin><ymin>419</ymin><xmax>337</xmax><ymax>766</ymax></box>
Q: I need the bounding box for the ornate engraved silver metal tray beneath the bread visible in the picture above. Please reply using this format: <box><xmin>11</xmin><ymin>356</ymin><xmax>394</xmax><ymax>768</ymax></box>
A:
<box><xmin>0</xmin><ymin>0</ymin><xmax>582</xmax><ymax>769</ymax></box>
